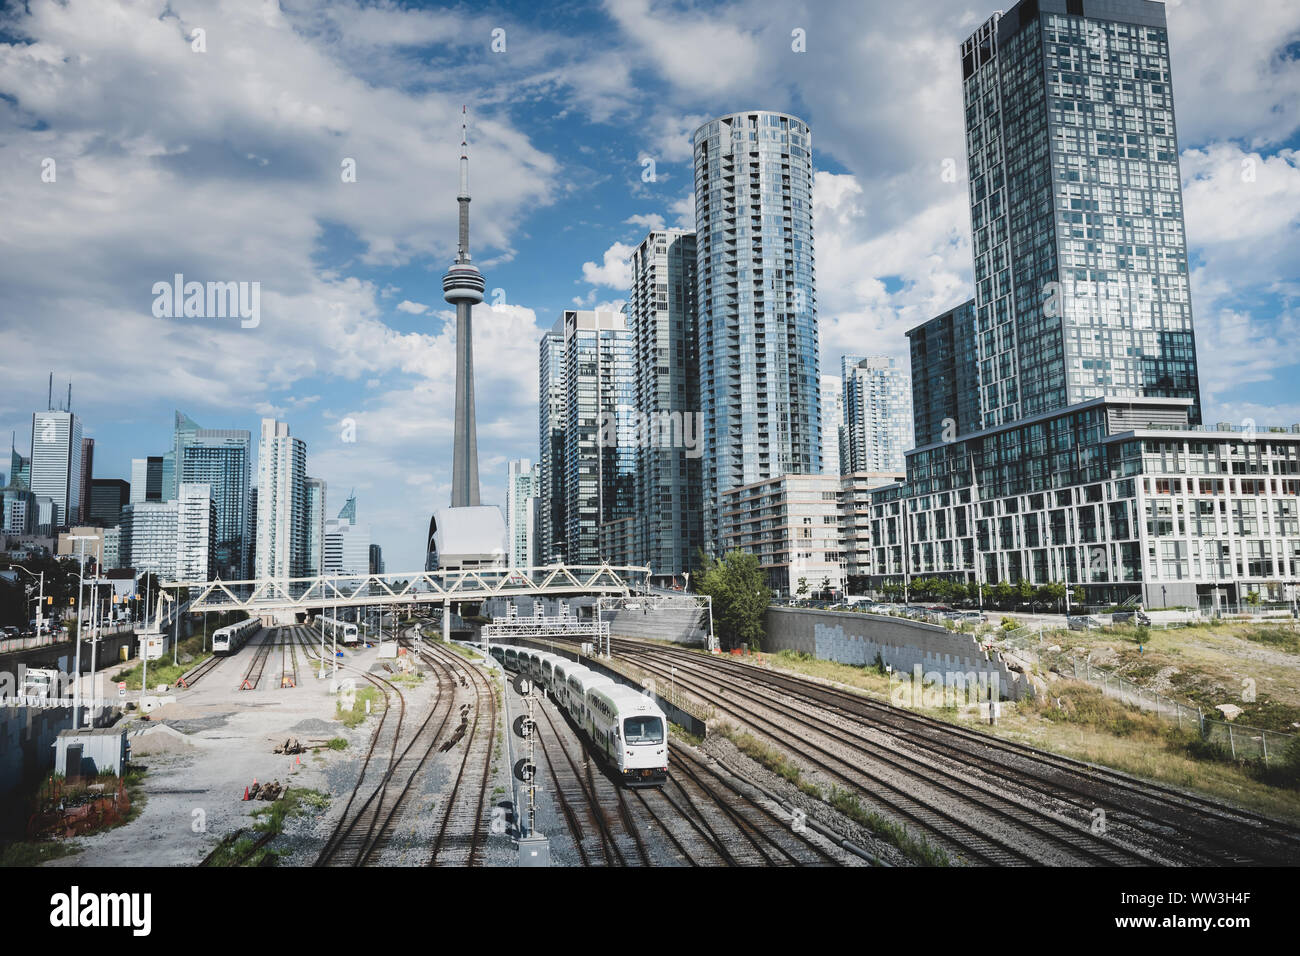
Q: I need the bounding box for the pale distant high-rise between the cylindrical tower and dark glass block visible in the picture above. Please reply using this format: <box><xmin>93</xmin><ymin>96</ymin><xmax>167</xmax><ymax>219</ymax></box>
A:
<box><xmin>840</xmin><ymin>355</ymin><xmax>913</xmax><ymax>475</ymax></box>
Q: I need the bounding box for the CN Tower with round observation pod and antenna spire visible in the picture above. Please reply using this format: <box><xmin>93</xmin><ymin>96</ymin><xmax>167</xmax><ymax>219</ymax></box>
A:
<box><xmin>442</xmin><ymin>107</ymin><xmax>486</xmax><ymax>507</ymax></box>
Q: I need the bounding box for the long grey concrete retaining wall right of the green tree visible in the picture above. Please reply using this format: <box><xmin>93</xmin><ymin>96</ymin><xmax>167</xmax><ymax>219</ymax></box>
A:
<box><xmin>763</xmin><ymin>607</ymin><xmax>1027</xmax><ymax>698</ymax></box>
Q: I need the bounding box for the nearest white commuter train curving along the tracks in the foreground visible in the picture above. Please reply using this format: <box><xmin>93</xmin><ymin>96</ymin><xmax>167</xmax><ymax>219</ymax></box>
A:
<box><xmin>493</xmin><ymin>646</ymin><xmax>668</xmax><ymax>786</ymax></box>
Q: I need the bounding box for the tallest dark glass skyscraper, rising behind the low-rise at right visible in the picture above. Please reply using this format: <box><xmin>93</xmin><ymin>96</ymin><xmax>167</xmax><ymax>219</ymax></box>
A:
<box><xmin>961</xmin><ymin>0</ymin><xmax>1200</xmax><ymax>428</ymax></box>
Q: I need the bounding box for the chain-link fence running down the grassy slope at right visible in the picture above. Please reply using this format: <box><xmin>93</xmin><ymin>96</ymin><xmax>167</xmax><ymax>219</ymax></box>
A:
<box><xmin>979</xmin><ymin>627</ymin><xmax>1296</xmax><ymax>763</ymax></box>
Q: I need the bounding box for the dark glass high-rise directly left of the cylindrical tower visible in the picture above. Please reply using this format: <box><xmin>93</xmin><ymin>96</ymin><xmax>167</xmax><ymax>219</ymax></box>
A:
<box><xmin>626</xmin><ymin>229</ymin><xmax>703</xmax><ymax>580</ymax></box>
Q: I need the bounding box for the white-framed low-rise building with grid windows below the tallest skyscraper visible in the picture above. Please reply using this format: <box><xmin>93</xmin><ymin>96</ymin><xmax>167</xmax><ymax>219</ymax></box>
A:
<box><xmin>871</xmin><ymin>398</ymin><xmax>1300</xmax><ymax>609</ymax></box>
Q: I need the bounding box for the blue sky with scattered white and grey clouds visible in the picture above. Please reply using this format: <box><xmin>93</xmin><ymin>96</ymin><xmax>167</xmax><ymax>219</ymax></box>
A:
<box><xmin>0</xmin><ymin>0</ymin><xmax>1300</xmax><ymax>570</ymax></box>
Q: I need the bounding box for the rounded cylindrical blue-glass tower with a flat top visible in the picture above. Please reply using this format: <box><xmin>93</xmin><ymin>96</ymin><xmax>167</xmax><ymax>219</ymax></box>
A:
<box><xmin>693</xmin><ymin>111</ymin><xmax>822</xmax><ymax>550</ymax></box>
